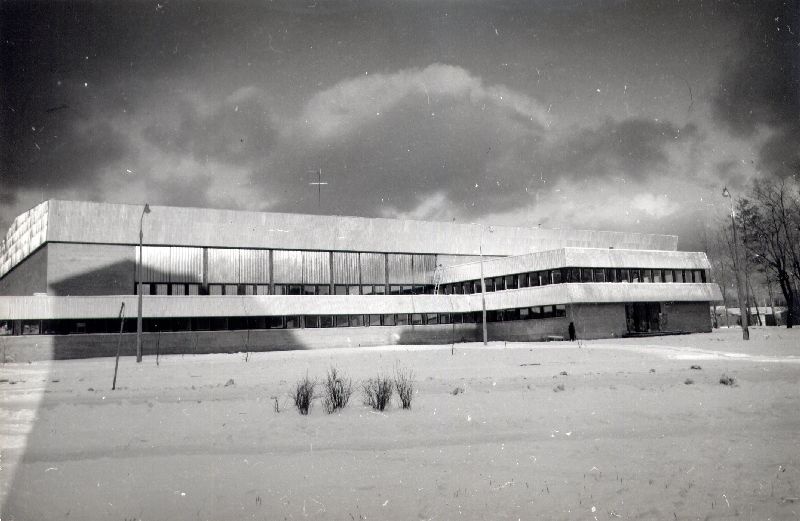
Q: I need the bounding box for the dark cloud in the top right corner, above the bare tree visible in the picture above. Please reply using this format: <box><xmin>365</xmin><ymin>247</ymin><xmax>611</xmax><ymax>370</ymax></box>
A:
<box><xmin>713</xmin><ymin>0</ymin><xmax>800</xmax><ymax>176</ymax></box>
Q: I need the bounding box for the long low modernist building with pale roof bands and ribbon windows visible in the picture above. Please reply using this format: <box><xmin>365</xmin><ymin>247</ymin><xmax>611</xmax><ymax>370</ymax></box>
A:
<box><xmin>0</xmin><ymin>200</ymin><xmax>721</xmax><ymax>360</ymax></box>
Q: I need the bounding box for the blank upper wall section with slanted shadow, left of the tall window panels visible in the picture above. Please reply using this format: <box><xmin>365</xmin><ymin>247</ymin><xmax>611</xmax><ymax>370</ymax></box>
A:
<box><xmin>46</xmin><ymin>243</ymin><xmax>136</xmax><ymax>296</ymax></box>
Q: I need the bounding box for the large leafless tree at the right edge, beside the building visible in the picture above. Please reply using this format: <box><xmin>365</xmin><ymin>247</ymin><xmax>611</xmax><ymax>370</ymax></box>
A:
<box><xmin>737</xmin><ymin>179</ymin><xmax>800</xmax><ymax>327</ymax></box>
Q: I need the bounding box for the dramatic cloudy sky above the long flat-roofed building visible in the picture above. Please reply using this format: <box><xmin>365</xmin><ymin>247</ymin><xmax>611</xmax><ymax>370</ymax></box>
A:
<box><xmin>0</xmin><ymin>0</ymin><xmax>800</xmax><ymax>250</ymax></box>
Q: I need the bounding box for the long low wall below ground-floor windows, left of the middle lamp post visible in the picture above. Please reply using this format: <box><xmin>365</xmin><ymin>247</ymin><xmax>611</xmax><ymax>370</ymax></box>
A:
<box><xmin>0</xmin><ymin>324</ymin><xmax>480</xmax><ymax>363</ymax></box>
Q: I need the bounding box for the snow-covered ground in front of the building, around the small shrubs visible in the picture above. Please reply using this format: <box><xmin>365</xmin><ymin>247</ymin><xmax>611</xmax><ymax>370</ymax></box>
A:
<box><xmin>0</xmin><ymin>328</ymin><xmax>800</xmax><ymax>521</ymax></box>
